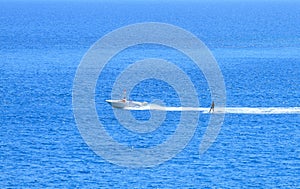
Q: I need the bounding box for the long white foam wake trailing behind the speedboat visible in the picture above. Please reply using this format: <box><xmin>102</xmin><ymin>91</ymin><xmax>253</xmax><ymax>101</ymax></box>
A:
<box><xmin>125</xmin><ymin>104</ymin><xmax>300</xmax><ymax>114</ymax></box>
